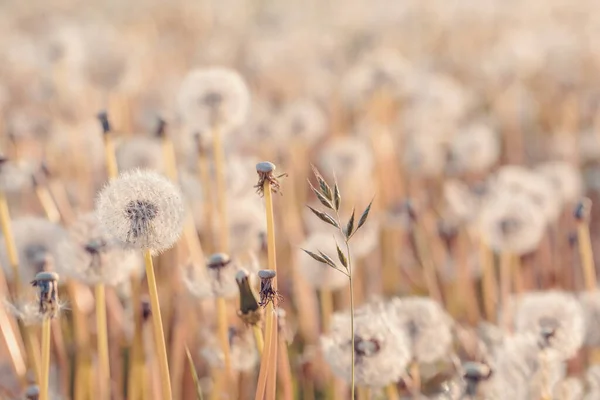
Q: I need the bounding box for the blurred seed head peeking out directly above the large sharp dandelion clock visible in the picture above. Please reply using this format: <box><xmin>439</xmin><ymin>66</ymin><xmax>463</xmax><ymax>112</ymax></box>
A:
<box><xmin>116</xmin><ymin>136</ymin><xmax>165</xmax><ymax>172</ymax></box>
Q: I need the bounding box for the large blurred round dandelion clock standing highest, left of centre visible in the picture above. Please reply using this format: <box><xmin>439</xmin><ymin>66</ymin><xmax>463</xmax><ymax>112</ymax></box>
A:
<box><xmin>177</xmin><ymin>67</ymin><xmax>250</xmax><ymax>132</ymax></box>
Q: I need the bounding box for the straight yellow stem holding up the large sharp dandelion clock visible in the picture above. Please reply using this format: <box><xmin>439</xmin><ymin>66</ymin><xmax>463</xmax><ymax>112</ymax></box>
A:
<box><xmin>144</xmin><ymin>250</ymin><xmax>171</xmax><ymax>400</ymax></box>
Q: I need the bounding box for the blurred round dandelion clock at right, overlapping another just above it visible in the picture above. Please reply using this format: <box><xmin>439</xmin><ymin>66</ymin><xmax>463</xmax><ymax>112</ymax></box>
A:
<box><xmin>476</xmin><ymin>193</ymin><xmax>546</xmax><ymax>255</ymax></box>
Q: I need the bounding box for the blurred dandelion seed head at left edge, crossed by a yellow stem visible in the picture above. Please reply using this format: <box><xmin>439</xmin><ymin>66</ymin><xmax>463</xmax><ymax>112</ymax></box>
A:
<box><xmin>0</xmin><ymin>217</ymin><xmax>67</xmax><ymax>282</ymax></box>
